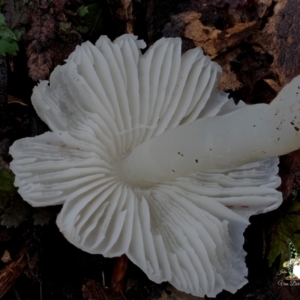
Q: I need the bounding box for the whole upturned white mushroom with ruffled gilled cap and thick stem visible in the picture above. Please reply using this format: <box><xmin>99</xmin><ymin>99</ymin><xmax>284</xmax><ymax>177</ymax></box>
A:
<box><xmin>10</xmin><ymin>35</ymin><xmax>300</xmax><ymax>297</ymax></box>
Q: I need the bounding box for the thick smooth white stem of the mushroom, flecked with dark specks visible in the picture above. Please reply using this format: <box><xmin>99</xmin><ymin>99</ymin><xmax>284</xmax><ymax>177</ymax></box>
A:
<box><xmin>116</xmin><ymin>76</ymin><xmax>300</xmax><ymax>186</ymax></box>
